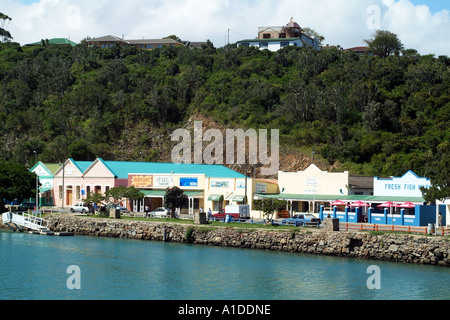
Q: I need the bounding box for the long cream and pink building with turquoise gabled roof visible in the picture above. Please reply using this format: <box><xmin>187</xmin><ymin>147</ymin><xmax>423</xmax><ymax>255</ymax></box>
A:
<box><xmin>53</xmin><ymin>158</ymin><xmax>253</xmax><ymax>214</ymax></box>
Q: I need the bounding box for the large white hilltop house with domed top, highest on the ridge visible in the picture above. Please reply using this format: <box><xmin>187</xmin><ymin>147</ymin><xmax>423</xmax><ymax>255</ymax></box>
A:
<box><xmin>237</xmin><ymin>18</ymin><xmax>319</xmax><ymax>51</ymax></box>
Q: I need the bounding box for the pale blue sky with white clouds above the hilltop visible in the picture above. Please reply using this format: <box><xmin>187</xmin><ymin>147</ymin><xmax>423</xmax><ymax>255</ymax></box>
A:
<box><xmin>0</xmin><ymin>0</ymin><xmax>450</xmax><ymax>56</ymax></box>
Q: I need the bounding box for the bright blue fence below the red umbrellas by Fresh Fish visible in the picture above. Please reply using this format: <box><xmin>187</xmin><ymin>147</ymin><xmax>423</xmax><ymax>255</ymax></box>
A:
<box><xmin>319</xmin><ymin>205</ymin><xmax>446</xmax><ymax>227</ymax></box>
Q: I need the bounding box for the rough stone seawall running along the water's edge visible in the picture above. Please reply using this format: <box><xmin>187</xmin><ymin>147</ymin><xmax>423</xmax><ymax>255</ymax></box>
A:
<box><xmin>39</xmin><ymin>216</ymin><xmax>450</xmax><ymax>267</ymax></box>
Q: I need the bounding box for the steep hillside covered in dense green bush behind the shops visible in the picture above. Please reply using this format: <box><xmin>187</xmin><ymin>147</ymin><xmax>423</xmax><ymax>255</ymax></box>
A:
<box><xmin>0</xmin><ymin>43</ymin><xmax>450</xmax><ymax>184</ymax></box>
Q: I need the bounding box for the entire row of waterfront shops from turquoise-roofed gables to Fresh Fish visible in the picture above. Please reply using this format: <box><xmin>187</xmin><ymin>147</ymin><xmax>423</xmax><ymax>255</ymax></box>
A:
<box><xmin>30</xmin><ymin>158</ymin><xmax>450</xmax><ymax>225</ymax></box>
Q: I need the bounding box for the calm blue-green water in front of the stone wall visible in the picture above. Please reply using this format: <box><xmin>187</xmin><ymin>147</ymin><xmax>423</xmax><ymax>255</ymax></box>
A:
<box><xmin>0</xmin><ymin>231</ymin><xmax>450</xmax><ymax>300</ymax></box>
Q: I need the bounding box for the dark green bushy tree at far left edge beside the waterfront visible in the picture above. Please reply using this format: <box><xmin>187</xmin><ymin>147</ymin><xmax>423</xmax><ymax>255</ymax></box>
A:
<box><xmin>0</xmin><ymin>160</ymin><xmax>36</xmax><ymax>212</ymax></box>
